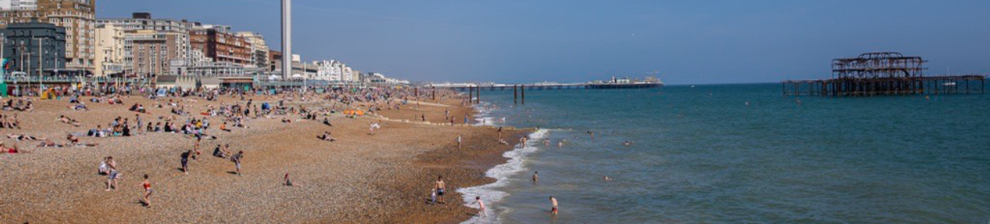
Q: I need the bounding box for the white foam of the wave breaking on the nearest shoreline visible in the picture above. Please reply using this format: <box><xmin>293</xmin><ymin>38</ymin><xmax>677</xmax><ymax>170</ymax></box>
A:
<box><xmin>457</xmin><ymin>129</ymin><xmax>548</xmax><ymax>223</ymax></box>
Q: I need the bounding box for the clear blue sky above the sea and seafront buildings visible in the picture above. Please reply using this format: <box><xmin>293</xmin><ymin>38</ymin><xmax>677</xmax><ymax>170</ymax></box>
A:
<box><xmin>96</xmin><ymin>0</ymin><xmax>990</xmax><ymax>84</ymax></box>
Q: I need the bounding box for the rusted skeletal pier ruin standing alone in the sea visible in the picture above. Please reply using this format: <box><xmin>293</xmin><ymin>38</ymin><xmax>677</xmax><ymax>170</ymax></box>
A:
<box><xmin>781</xmin><ymin>52</ymin><xmax>986</xmax><ymax>97</ymax></box>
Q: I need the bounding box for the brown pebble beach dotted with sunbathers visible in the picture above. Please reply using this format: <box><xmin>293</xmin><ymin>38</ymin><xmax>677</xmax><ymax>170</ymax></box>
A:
<box><xmin>0</xmin><ymin>92</ymin><xmax>527</xmax><ymax>223</ymax></box>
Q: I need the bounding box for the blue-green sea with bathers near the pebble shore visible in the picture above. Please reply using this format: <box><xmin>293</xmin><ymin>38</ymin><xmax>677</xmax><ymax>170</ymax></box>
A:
<box><xmin>458</xmin><ymin>84</ymin><xmax>990</xmax><ymax>224</ymax></box>
